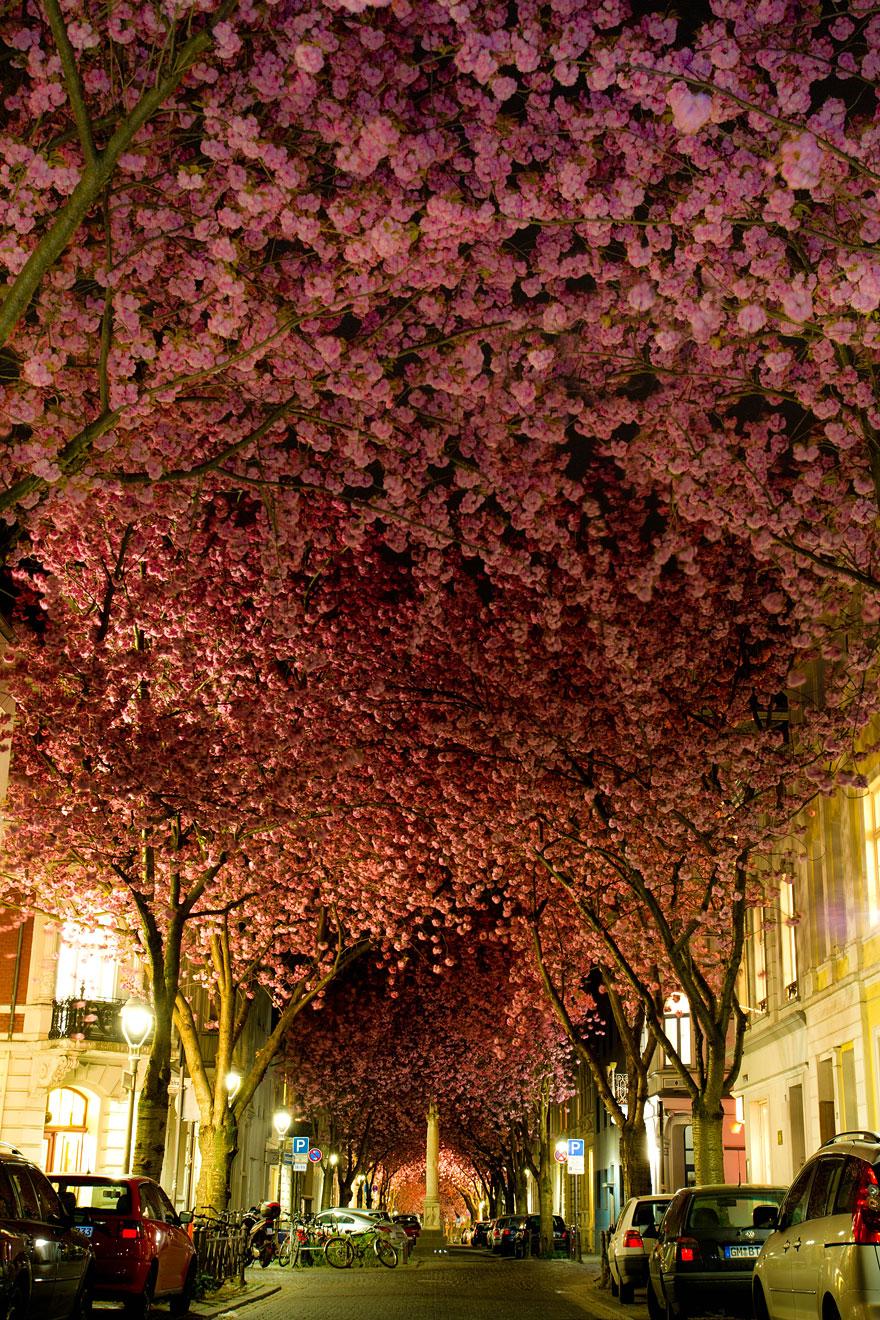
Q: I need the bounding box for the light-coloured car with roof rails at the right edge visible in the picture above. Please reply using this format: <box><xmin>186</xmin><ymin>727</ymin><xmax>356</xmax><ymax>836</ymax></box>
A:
<box><xmin>752</xmin><ymin>1131</ymin><xmax>880</xmax><ymax>1320</ymax></box>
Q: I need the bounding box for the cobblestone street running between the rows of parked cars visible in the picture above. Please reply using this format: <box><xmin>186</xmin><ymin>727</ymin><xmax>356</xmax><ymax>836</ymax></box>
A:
<box><xmin>180</xmin><ymin>1253</ymin><xmax>620</xmax><ymax>1320</ymax></box>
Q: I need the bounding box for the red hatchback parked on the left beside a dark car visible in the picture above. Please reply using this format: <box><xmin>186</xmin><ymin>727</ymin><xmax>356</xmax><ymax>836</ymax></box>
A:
<box><xmin>50</xmin><ymin>1173</ymin><xmax>197</xmax><ymax>1320</ymax></box>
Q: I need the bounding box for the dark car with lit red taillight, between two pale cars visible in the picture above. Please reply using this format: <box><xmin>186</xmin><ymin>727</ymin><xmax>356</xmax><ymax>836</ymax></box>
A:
<box><xmin>646</xmin><ymin>1183</ymin><xmax>785</xmax><ymax>1320</ymax></box>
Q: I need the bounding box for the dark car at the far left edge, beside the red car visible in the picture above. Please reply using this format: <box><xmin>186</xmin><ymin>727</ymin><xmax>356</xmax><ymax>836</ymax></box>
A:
<box><xmin>0</xmin><ymin>1147</ymin><xmax>94</xmax><ymax>1320</ymax></box>
